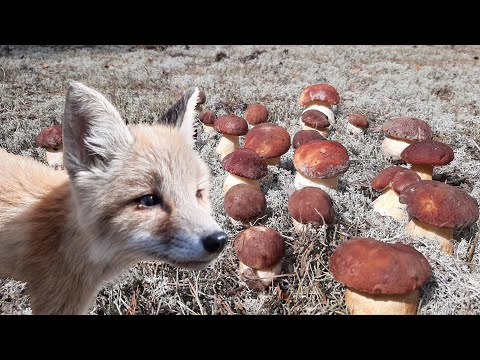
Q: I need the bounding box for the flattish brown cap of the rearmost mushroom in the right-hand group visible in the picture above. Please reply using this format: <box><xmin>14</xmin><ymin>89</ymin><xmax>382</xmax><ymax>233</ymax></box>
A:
<box><xmin>382</xmin><ymin>116</ymin><xmax>433</xmax><ymax>141</ymax></box>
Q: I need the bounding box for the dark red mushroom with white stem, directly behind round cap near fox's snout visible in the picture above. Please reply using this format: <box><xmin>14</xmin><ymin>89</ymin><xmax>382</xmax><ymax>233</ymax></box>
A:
<box><xmin>222</xmin><ymin>148</ymin><xmax>268</xmax><ymax>193</ymax></box>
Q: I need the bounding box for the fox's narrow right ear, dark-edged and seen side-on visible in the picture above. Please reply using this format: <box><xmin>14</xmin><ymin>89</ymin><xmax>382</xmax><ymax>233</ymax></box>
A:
<box><xmin>158</xmin><ymin>87</ymin><xmax>200</xmax><ymax>147</ymax></box>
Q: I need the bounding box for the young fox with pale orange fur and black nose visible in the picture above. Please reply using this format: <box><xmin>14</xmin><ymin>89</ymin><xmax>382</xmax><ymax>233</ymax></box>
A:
<box><xmin>0</xmin><ymin>81</ymin><xmax>228</xmax><ymax>314</ymax></box>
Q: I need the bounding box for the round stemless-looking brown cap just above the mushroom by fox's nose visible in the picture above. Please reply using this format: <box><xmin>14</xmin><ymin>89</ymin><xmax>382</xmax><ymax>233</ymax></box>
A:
<box><xmin>223</xmin><ymin>184</ymin><xmax>267</xmax><ymax>221</ymax></box>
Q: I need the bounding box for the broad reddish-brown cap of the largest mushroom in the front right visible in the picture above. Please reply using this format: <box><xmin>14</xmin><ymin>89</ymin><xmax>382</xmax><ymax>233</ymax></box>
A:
<box><xmin>329</xmin><ymin>238</ymin><xmax>432</xmax><ymax>295</ymax></box>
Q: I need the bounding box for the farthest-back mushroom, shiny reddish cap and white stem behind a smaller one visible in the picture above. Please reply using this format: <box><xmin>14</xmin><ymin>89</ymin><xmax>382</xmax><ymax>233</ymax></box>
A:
<box><xmin>298</xmin><ymin>84</ymin><xmax>340</xmax><ymax>125</ymax></box>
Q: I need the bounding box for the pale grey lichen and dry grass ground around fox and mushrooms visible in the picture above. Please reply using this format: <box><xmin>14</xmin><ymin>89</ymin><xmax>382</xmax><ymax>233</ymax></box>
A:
<box><xmin>0</xmin><ymin>46</ymin><xmax>480</xmax><ymax>314</ymax></box>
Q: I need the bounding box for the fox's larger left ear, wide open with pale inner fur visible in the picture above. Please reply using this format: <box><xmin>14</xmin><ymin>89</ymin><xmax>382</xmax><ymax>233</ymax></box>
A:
<box><xmin>62</xmin><ymin>81</ymin><xmax>133</xmax><ymax>175</ymax></box>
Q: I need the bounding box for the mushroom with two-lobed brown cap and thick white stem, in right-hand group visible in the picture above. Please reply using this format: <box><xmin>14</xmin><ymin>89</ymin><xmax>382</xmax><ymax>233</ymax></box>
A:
<box><xmin>370</xmin><ymin>166</ymin><xmax>420</xmax><ymax>220</ymax></box>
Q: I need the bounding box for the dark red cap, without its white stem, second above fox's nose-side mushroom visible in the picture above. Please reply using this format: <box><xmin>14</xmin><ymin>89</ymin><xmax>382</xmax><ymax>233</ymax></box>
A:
<box><xmin>222</xmin><ymin>148</ymin><xmax>268</xmax><ymax>180</ymax></box>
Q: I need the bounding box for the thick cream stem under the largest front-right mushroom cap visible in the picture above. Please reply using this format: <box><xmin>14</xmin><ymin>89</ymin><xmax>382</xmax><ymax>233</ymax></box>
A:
<box><xmin>345</xmin><ymin>288</ymin><xmax>420</xmax><ymax>315</ymax></box>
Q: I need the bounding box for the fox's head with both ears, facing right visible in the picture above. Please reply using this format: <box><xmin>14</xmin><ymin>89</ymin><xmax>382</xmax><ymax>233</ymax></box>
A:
<box><xmin>63</xmin><ymin>82</ymin><xmax>227</xmax><ymax>269</ymax></box>
